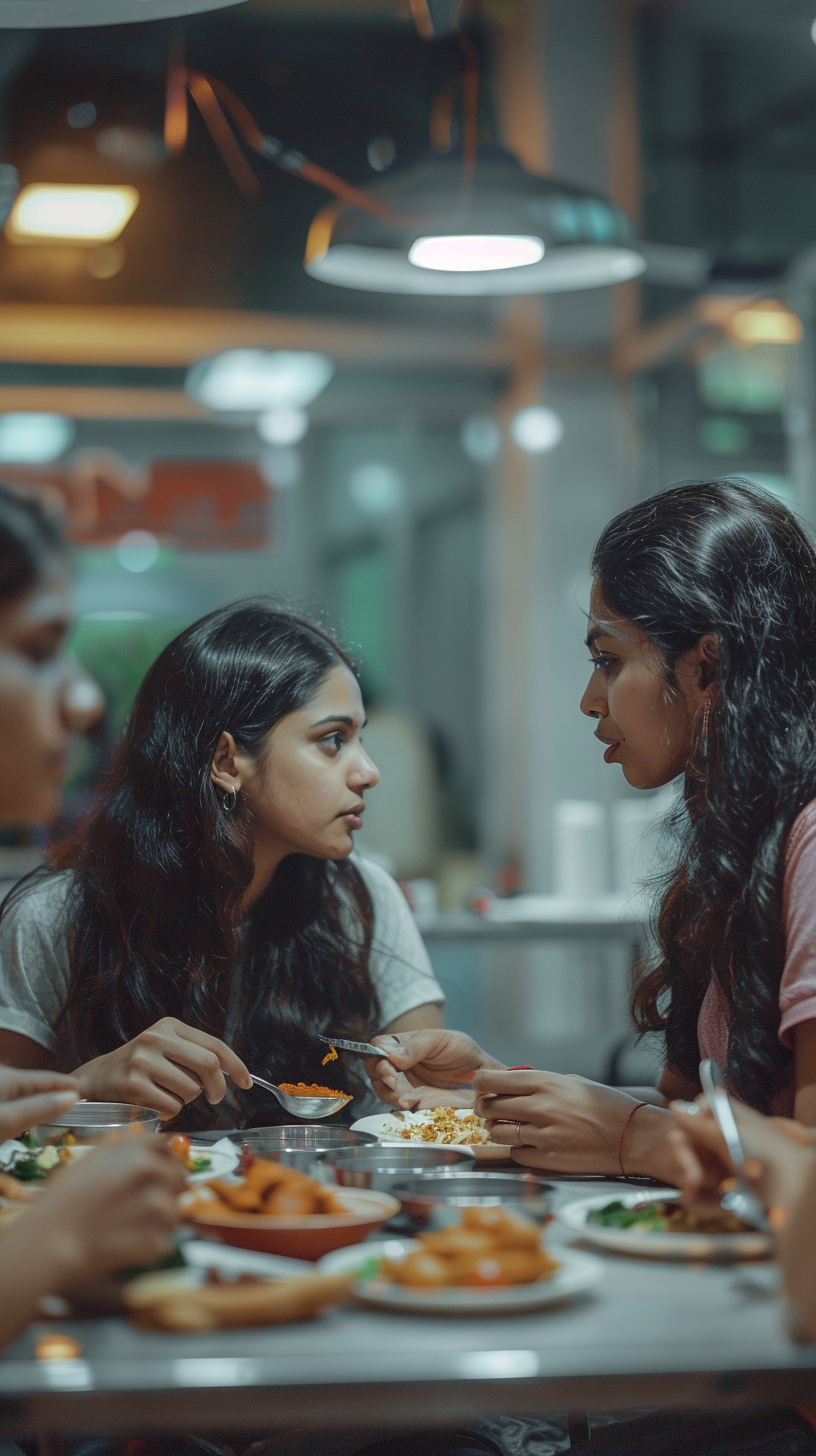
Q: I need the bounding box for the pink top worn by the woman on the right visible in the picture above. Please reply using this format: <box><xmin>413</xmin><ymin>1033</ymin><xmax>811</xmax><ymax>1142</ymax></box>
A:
<box><xmin>697</xmin><ymin>799</ymin><xmax>816</xmax><ymax>1117</ymax></box>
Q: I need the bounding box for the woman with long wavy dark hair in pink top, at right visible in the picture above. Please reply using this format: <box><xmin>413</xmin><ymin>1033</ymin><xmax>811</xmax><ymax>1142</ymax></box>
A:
<box><xmin>373</xmin><ymin>480</ymin><xmax>816</xmax><ymax>1179</ymax></box>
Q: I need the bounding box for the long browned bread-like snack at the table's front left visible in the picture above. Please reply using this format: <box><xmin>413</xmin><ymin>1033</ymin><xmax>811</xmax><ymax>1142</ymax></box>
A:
<box><xmin>124</xmin><ymin>1274</ymin><xmax>351</xmax><ymax>1334</ymax></box>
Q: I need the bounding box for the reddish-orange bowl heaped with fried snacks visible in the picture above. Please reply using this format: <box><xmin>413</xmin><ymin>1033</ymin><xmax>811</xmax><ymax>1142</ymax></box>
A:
<box><xmin>189</xmin><ymin>1188</ymin><xmax>401</xmax><ymax>1262</ymax></box>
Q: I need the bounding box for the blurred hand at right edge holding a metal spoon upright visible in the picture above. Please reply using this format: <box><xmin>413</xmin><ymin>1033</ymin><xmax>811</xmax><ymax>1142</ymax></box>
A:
<box><xmin>669</xmin><ymin>1096</ymin><xmax>816</xmax><ymax>1210</ymax></box>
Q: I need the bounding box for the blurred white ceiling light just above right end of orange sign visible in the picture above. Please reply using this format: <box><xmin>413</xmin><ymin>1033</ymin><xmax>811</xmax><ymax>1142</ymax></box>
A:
<box><xmin>185</xmin><ymin>349</ymin><xmax>334</xmax><ymax>416</ymax></box>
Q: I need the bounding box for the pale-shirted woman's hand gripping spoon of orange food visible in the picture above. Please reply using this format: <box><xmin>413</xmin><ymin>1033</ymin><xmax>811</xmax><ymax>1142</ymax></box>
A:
<box><xmin>74</xmin><ymin>1016</ymin><xmax>254</xmax><ymax>1121</ymax></box>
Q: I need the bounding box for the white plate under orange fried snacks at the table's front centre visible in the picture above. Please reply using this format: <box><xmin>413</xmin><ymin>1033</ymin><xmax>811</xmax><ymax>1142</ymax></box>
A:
<box><xmin>318</xmin><ymin>1239</ymin><xmax>606</xmax><ymax>1315</ymax></box>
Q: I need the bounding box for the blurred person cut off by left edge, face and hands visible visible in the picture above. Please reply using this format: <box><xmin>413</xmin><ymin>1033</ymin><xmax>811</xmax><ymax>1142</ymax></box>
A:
<box><xmin>0</xmin><ymin>485</ymin><xmax>185</xmax><ymax>1345</ymax></box>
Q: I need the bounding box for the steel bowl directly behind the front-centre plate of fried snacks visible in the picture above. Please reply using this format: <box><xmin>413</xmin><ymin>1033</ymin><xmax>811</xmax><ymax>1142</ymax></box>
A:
<box><xmin>389</xmin><ymin>1168</ymin><xmax>552</xmax><ymax>1224</ymax></box>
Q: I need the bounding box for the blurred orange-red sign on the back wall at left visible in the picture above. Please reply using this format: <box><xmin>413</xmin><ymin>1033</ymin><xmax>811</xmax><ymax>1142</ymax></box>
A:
<box><xmin>0</xmin><ymin>450</ymin><xmax>271</xmax><ymax>550</ymax></box>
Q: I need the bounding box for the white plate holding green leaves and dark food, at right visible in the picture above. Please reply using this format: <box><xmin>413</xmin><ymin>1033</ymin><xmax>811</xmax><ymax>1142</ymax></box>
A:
<box><xmin>558</xmin><ymin>1188</ymin><xmax>772</xmax><ymax>1261</ymax></box>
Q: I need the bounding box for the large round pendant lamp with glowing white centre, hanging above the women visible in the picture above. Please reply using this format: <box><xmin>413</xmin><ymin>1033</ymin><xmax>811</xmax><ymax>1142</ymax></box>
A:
<box><xmin>303</xmin><ymin>146</ymin><xmax>646</xmax><ymax>297</ymax></box>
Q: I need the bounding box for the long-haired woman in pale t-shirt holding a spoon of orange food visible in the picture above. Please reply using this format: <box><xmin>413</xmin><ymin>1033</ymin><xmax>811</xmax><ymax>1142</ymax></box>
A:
<box><xmin>0</xmin><ymin>598</ymin><xmax>444</xmax><ymax>1127</ymax></box>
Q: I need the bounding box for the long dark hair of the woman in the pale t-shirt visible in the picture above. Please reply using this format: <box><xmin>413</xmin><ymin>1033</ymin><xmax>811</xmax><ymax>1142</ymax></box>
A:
<box><xmin>12</xmin><ymin>598</ymin><xmax>379</xmax><ymax>1123</ymax></box>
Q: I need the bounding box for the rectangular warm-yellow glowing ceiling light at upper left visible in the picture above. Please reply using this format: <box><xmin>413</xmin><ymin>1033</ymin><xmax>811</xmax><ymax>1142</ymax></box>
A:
<box><xmin>6</xmin><ymin>182</ymin><xmax>138</xmax><ymax>243</ymax></box>
